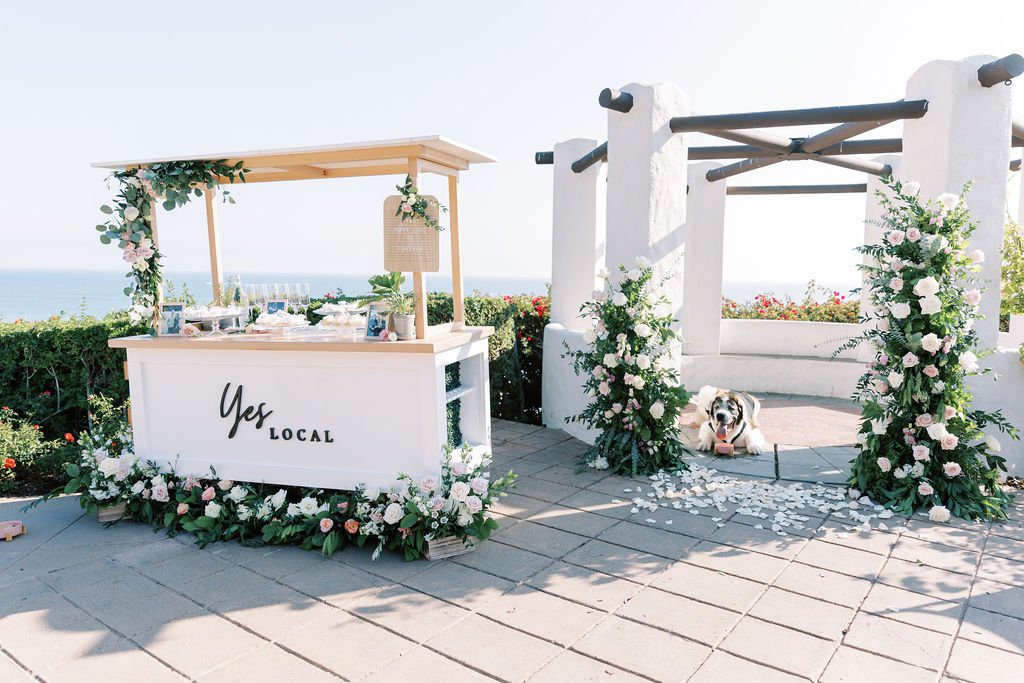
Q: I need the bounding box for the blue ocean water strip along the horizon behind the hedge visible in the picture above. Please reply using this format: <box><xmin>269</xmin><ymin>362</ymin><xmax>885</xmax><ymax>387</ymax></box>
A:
<box><xmin>0</xmin><ymin>269</ymin><xmax>853</xmax><ymax>322</ymax></box>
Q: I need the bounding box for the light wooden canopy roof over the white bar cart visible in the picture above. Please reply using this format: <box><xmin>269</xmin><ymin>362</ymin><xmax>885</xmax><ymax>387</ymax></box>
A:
<box><xmin>93</xmin><ymin>135</ymin><xmax>497</xmax><ymax>182</ymax></box>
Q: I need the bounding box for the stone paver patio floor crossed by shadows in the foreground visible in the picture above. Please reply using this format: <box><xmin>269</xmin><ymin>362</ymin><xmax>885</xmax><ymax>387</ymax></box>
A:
<box><xmin>0</xmin><ymin>409</ymin><xmax>1024</xmax><ymax>683</ymax></box>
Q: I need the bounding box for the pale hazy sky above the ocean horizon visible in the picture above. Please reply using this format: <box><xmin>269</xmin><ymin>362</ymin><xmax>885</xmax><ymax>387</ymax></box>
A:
<box><xmin>0</xmin><ymin>0</ymin><xmax>1024</xmax><ymax>282</ymax></box>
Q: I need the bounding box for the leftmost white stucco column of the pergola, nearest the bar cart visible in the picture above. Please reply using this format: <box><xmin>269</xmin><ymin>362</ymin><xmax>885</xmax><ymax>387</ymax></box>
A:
<box><xmin>551</xmin><ymin>138</ymin><xmax>606</xmax><ymax>330</ymax></box>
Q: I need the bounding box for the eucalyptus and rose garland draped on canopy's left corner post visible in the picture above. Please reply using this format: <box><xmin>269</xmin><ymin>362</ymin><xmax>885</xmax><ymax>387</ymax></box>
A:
<box><xmin>96</xmin><ymin>160</ymin><xmax>248</xmax><ymax>328</ymax></box>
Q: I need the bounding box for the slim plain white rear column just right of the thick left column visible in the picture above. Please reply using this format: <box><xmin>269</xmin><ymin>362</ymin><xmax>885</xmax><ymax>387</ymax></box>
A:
<box><xmin>680</xmin><ymin>162</ymin><xmax>726</xmax><ymax>355</ymax></box>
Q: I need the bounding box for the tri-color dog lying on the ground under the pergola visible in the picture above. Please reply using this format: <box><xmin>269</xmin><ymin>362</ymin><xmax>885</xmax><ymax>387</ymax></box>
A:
<box><xmin>693</xmin><ymin>386</ymin><xmax>766</xmax><ymax>455</ymax></box>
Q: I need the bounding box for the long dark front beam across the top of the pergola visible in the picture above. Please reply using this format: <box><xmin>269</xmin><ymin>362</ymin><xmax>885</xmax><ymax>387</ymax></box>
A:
<box><xmin>669</xmin><ymin>99</ymin><xmax>928</xmax><ymax>133</ymax></box>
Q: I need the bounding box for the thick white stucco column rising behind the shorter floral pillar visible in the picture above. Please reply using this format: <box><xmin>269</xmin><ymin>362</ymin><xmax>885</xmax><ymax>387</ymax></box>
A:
<box><xmin>605</xmin><ymin>83</ymin><xmax>689</xmax><ymax>317</ymax></box>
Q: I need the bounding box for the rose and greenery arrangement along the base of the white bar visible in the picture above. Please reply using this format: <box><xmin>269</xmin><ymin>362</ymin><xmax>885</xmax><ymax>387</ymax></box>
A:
<box><xmin>40</xmin><ymin>398</ymin><xmax>516</xmax><ymax>560</ymax></box>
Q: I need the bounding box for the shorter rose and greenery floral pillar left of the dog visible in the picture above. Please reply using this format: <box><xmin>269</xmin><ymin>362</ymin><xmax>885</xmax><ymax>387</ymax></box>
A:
<box><xmin>565</xmin><ymin>258</ymin><xmax>690</xmax><ymax>475</ymax></box>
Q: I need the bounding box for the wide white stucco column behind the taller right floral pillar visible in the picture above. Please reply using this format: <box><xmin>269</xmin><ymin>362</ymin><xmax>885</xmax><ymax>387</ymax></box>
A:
<box><xmin>900</xmin><ymin>56</ymin><xmax>1012</xmax><ymax>348</ymax></box>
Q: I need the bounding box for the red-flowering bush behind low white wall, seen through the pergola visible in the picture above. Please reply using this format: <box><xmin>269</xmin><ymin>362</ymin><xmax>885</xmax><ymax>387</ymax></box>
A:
<box><xmin>722</xmin><ymin>281</ymin><xmax>860</xmax><ymax>323</ymax></box>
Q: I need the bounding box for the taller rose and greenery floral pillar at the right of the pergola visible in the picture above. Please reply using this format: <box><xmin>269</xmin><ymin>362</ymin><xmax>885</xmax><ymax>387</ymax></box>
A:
<box><xmin>847</xmin><ymin>179</ymin><xmax>1017</xmax><ymax>521</ymax></box>
